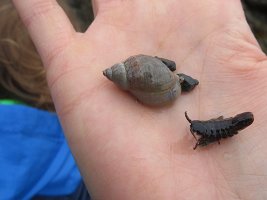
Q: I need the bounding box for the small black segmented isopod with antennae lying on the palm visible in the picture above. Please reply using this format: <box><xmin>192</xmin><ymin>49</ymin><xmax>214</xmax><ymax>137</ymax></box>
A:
<box><xmin>185</xmin><ymin>112</ymin><xmax>254</xmax><ymax>149</ymax></box>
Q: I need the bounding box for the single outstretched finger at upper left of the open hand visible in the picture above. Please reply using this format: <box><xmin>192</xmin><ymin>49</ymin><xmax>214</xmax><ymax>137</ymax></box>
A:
<box><xmin>13</xmin><ymin>0</ymin><xmax>75</xmax><ymax>66</ymax></box>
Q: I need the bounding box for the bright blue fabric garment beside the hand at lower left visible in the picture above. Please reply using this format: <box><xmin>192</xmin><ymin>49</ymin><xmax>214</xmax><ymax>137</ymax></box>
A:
<box><xmin>0</xmin><ymin>105</ymin><xmax>81</xmax><ymax>200</ymax></box>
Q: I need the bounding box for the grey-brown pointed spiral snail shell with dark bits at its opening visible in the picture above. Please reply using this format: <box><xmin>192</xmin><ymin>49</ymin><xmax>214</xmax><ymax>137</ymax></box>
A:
<box><xmin>103</xmin><ymin>55</ymin><xmax>198</xmax><ymax>106</ymax></box>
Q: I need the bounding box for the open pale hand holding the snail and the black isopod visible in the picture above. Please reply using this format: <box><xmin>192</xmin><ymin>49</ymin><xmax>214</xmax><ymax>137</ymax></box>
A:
<box><xmin>13</xmin><ymin>0</ymin><xmax>267</xmax><ymax>200</ymax></box>
